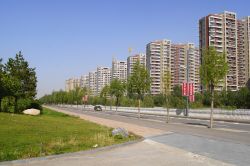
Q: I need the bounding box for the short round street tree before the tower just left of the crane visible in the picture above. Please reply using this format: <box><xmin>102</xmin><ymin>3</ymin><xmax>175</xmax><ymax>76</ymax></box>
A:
<box><xmin>110</xmin><ymin>79</ymin><xmax>126</xmax><ymax>111</ymax></box>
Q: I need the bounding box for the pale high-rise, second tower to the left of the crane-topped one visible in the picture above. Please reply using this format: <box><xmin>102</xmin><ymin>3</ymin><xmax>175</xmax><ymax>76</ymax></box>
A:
<box><xmin>95</xmin><ymin>67</ymin><xmax>111</xmax><ymax>95</ymax></box>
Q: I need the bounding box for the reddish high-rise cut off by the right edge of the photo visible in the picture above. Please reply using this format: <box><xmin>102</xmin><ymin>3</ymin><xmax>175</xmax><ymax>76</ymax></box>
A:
<box><xmin>237</xmin><ymin>16</ymin><xmax>250</xmax><ymax>87</ymax></box>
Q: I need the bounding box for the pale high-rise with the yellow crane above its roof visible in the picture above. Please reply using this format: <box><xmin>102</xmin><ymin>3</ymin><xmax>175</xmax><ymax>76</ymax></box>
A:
<box><xmin>127</xmin><ymin>53</ymin><xmax>146</xmax><ymax>76</ymax></box>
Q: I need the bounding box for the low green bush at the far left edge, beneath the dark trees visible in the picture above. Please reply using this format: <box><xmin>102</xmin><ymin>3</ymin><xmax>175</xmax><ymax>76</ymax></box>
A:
<box><xmin>1</xmin><ymin>96</ymin><xmax>15</xmax><ymax>113</ymax></box>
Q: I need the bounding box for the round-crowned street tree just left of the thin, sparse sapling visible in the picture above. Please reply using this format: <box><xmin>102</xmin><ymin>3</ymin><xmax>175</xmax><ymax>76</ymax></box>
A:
<box><xmin>128</xmin><ymin>61</ymin><xmax>151</xmax><ymax>119</ymax></box>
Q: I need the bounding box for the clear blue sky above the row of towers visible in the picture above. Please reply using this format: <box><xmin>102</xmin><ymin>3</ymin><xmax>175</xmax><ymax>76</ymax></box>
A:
<box><xmin>0</xmin><ymin>0</ymin><xmax>250</xmax><ymax>98</ymax></box>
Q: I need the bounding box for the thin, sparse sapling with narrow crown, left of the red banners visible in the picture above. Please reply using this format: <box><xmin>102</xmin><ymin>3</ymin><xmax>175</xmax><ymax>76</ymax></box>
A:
<box><xmin>162</xmin><ymin>70</ymin><xmax>171</xmax><ymax>123</ymax></box>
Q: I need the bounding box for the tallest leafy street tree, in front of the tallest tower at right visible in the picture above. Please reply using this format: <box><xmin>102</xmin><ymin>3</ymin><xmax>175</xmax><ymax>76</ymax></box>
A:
<box><xmin>200</xmin><ymin>47</ymin><xmax>228</xmax><ymax>128</ymax></box>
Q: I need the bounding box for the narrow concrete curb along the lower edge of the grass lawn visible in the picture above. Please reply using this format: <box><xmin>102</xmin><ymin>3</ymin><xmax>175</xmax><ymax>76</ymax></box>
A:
<box><xmin>0</xmin><ymin>138</ymin><xmax>145</xmax><ymax>166</ymax></box>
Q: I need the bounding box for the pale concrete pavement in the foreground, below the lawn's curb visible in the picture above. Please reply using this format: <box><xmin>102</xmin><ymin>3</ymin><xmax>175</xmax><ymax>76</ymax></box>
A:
<box><xmin>0</xmin><ymin>139</ymin><xmax>230</xmax><ymax>166</ymax></box>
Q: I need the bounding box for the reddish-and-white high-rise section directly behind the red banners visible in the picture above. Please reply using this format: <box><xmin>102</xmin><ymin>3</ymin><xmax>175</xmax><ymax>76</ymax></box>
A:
<box><xmin>171</xmin><ymin>43</ymin><xmax>200</xmax><ymax>92</ymax></box>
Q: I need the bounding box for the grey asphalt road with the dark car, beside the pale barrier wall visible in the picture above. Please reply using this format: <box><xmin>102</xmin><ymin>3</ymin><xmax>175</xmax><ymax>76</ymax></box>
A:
<box><xmin>55</xmin><ymin>107</ymin><xmax>250</xmax><ymax>146</ymax></box>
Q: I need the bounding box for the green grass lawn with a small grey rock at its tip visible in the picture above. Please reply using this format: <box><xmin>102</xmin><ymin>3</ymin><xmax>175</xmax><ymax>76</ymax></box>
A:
<box><xmin>0</xmin><ymin>108</ymin><xmax>138</xmax><ymax>161</ymax></box>
